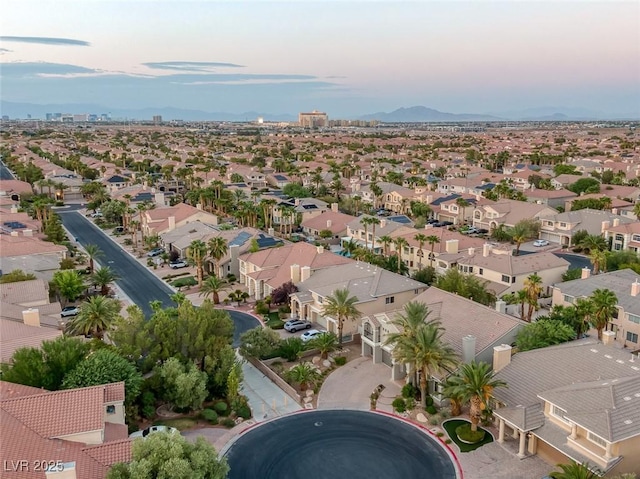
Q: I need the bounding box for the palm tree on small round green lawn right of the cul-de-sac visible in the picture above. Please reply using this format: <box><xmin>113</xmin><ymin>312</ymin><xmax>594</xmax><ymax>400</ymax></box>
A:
<box><xmin>449</xmin><ymin>361</ymin><xmax>507</xmax><ymax>431</ymax></box>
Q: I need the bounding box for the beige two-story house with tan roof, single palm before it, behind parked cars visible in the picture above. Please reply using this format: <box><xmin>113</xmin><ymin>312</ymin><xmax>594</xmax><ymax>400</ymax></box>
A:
<box><xmin>291</xmin><ymin>260</ymin><xmax>427</xmax><ymax>336</ymax></box>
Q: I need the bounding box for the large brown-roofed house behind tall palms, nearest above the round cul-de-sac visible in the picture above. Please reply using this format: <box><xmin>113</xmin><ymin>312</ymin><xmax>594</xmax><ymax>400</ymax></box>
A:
<box><xmin>360</xmin><ymin>287</ymin><xmax>526</xmax><ymax>384</ymax></box>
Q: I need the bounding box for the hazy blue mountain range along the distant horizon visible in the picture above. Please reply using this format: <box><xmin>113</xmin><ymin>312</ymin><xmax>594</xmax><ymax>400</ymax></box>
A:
<box><xmin>0</xmin><ymin>100</ymin><xmax>640</xmax><ymax>123</ymax></box>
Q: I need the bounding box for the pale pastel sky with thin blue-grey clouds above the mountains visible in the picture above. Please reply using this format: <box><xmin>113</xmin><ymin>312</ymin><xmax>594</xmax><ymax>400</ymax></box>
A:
<box><xmin>0</xmin><ymin>0</ymin><xmax>640</xmax><ymax>118</ymax></box>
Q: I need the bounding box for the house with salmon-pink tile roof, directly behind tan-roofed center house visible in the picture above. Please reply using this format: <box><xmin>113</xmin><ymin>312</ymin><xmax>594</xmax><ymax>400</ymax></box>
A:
<box><xmin>239</xmin><ymin>242</ymin><xmax>353</xmax><ymax>299</ymax></box>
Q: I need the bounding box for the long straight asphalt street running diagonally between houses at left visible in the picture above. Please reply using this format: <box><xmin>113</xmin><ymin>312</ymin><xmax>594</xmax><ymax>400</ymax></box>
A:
<box><xmin>56</xmin><ymin>212</ymin><xmax>260</xmax><ymax>348</ymax></box>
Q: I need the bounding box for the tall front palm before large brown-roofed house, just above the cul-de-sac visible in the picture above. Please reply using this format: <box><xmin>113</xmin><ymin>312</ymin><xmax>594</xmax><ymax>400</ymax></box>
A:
<box><xmin>393</xmin><ymin>324</ymin><xmax>458</xmax><ymax>408</ymax></box>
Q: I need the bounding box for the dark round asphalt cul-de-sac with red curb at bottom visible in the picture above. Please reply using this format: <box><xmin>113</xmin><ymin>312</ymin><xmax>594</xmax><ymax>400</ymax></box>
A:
<box><xmin>225</xmin><ymin>410</ymin><xmax>456</xmax><ymax>479</ymax></box>
